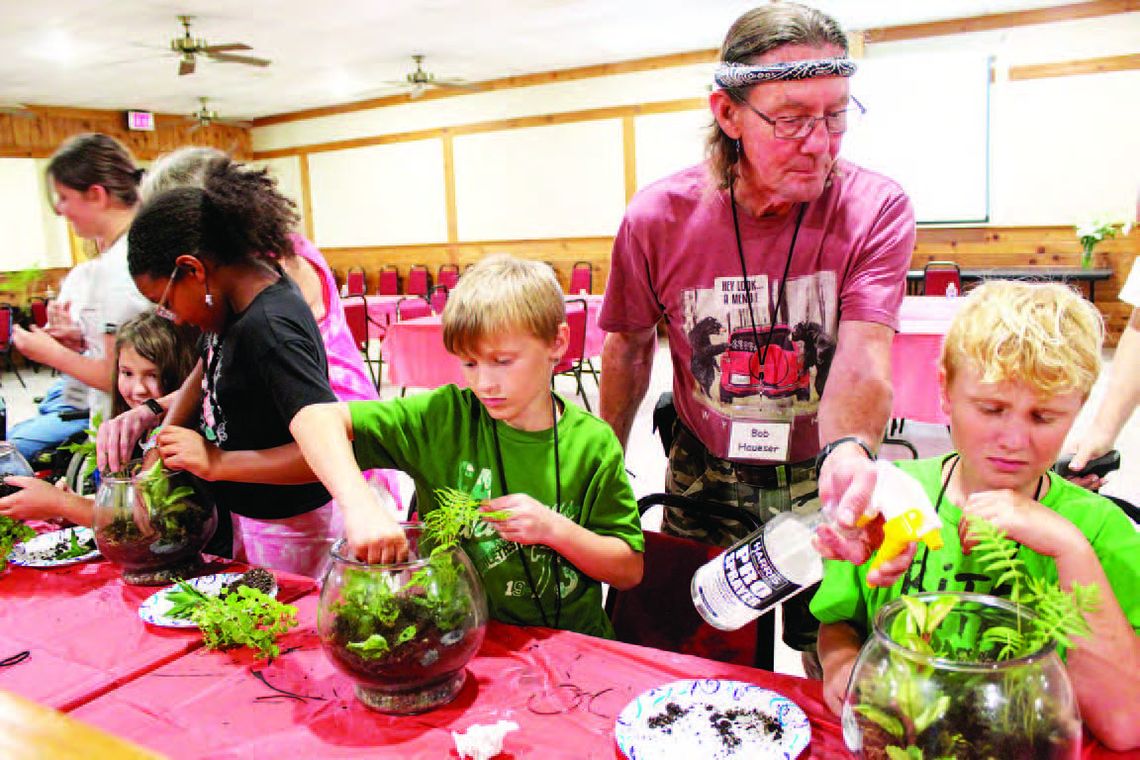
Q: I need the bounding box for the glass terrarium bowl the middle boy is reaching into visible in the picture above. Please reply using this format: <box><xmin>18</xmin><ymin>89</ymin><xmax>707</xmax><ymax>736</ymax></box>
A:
<box><xmin>317</xmin><ymin>523</ymin><xmax>487</xmax><ymax>714</ymax></box>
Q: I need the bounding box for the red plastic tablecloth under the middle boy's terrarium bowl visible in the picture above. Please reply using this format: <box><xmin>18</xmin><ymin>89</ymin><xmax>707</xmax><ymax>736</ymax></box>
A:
<box><xmin>74</xmin><ymin>596</ymin><xmax>847</xmax><ymax>760</ymax></box>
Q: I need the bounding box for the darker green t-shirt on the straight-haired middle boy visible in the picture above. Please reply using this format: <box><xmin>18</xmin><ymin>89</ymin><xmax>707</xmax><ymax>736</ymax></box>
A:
<box><xmin>349</xmin><ymin>385</ymin><xmax>644</xmax><ymax>638</ymax></box>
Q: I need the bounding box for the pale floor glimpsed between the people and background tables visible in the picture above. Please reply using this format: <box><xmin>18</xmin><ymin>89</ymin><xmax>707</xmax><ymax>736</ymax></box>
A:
<box><xmin>0</xmin><ymin>340</ymin><xmax>1140</xmax><ymax>675</ymax></box>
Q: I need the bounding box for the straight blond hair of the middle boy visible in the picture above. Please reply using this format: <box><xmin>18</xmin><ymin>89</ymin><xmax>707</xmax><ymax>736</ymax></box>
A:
<box><xmin>443</xmin><ymin>254</ymin><xmax>567</xmax><ymax>356</ymax></box>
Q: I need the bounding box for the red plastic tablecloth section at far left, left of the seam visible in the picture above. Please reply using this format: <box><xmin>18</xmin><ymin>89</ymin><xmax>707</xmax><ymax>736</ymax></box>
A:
<box><xmin>0</xmin><ymin>561</ymin><xmax>316</xmax><ymax>712</ymax></box>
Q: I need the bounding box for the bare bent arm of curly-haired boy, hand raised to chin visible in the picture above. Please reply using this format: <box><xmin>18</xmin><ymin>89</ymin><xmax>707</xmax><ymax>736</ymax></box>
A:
<box><xmin>962</xmin><ymin>491</ymin><xmax>1140</xmax><ymax>750</ymax></box>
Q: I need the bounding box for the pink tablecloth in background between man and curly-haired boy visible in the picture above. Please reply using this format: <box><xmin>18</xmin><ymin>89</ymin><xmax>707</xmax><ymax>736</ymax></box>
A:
<box><xmin>890</xmin><ymin>296</ymin><xmax>962</xmax><ymax>425</ymax></box>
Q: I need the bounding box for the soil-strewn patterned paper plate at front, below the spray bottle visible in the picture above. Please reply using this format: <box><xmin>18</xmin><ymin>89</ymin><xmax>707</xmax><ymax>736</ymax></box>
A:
<box><xmin>613</xmin><ymin>679</ymin><xmax>812</xmax><ymax>760</ymax></box>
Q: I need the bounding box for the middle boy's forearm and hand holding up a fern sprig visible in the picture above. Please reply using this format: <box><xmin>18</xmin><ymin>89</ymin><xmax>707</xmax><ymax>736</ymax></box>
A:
<box><xmin>483</xmin><ymin>493</ymin><xmax>644</xmax><ymax>590</ymax></box>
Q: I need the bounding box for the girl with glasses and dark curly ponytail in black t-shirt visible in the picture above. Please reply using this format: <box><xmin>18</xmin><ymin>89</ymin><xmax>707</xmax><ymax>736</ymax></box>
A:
<box><xmin>99</xmin><ymin>158</ymin><xmax>404</xmax><ymax>577</ymax></box>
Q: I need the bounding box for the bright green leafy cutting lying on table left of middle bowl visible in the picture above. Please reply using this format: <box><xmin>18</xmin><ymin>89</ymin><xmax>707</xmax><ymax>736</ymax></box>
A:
<box><xmin>166</xmin><ymin>567</ymin><xmax>296</xmax><ymax>659</ymax></box>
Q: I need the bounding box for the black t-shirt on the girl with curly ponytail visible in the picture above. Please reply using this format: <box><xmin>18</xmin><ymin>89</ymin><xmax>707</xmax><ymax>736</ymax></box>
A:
<box><xmin>201</xmin><ymin>277</ymin><xmax>336</xmax><ymax>520</ymax></box>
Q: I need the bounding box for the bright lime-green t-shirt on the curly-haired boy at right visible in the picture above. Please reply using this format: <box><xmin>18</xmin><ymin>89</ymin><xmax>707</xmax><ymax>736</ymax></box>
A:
<box><xmin>812</xmin><ymin>457</ymin><xmax>1140</xmax><ymax>635</ymax></box>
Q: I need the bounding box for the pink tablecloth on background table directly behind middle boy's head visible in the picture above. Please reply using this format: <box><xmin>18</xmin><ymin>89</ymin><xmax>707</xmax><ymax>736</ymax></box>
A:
<box><xmin>383</xmin><ymin>295</ymin><xmax>605</xmax><ymax>387</ymax></box>
